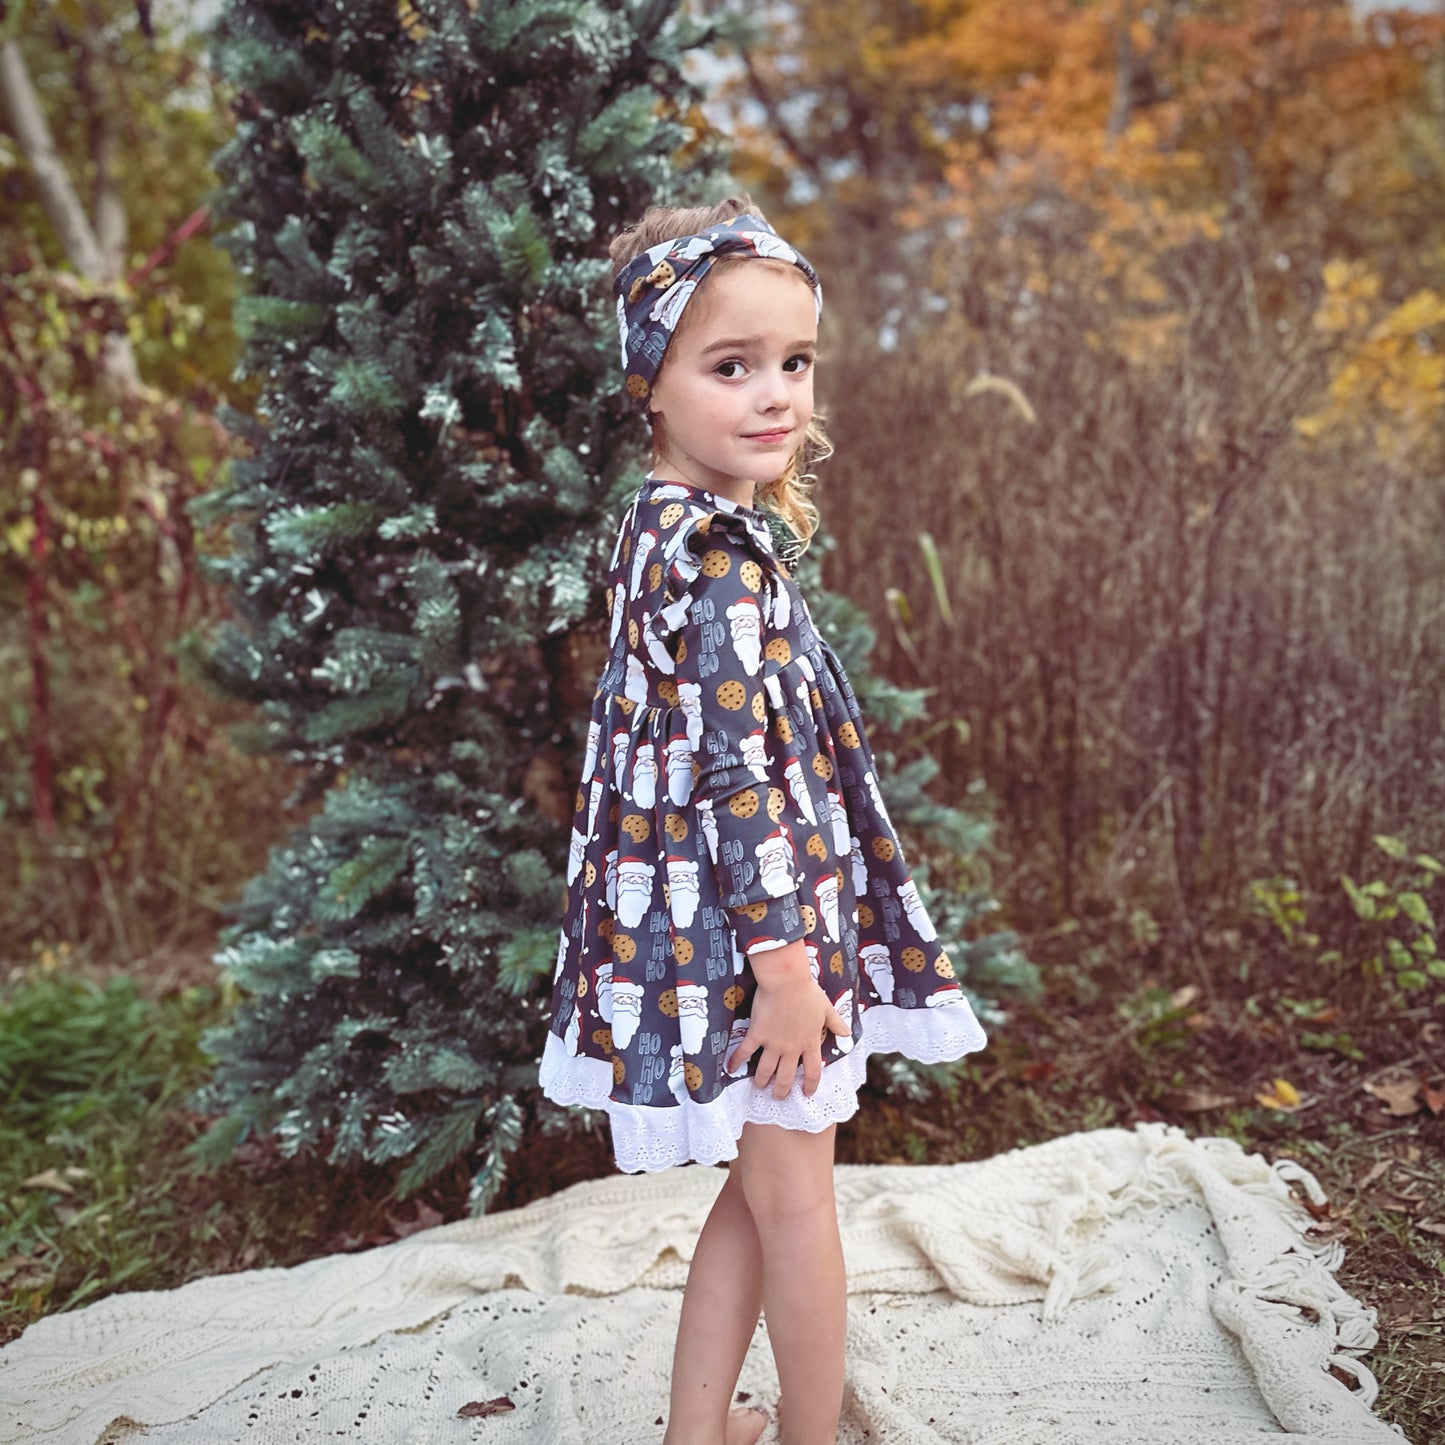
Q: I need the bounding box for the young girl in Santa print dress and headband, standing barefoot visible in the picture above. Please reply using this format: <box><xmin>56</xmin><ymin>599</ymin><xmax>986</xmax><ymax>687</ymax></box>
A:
<box><xmin>540</xmin><ymin>197</ymin><xmax>985</xmax><ymax>1445</ymax></box>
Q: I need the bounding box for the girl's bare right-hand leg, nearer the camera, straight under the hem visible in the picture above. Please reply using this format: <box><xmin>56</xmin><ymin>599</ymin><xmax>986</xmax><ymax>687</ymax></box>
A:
<box><xmin>737</xmin><ymin>1124</ymin><xmax>848</xmax><ymax>1445</ymax></box>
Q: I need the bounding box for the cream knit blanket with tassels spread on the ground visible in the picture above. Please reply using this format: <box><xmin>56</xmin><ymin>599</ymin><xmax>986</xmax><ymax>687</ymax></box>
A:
<box><xmin>0</xmin><ymin>1124</ymin><xmax>1405</xmax><ymax>1445</ymax></box>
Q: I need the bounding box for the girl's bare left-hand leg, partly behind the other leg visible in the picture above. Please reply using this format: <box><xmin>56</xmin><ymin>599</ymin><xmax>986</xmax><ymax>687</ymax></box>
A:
<box><xmin>665</xmin><ymin>1162</ymin><xmax>766</xmax><ymax>1445</ymax></box>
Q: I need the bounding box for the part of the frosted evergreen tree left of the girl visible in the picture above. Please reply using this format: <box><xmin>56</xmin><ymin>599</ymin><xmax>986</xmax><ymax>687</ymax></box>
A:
<box><xmin>195</xmin><ymin>0</ymin><xmax>1034</xmax><ymax>1209</ymax></box>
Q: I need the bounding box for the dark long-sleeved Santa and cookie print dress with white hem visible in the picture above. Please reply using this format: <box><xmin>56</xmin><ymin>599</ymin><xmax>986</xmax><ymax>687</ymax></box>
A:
<box><xmin>540</xmin><ymin>477</ymin><xmax>987</xmax><ymax>1172</ymax></box>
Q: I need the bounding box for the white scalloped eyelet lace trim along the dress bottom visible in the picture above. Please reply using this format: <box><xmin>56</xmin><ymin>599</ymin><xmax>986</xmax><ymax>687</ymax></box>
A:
<box><xmin>538</xmin><ymin>1000</ymin><xmax>988</xmax><ymax>1173</ymax></box>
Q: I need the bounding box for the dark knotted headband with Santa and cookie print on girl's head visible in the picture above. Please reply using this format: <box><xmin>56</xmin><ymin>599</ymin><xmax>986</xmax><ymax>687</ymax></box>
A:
<box><xmin>613</xmin><ymin>215</ymin><xmax>822</xmax><ymax>410</ymax></box>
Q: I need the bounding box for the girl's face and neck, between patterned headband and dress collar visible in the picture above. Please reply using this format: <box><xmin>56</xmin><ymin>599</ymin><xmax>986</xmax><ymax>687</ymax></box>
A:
<box><xmin>652</xmin><ymin>260</ymin><xmax>818</xmax><ymax>504</ymax></box>
